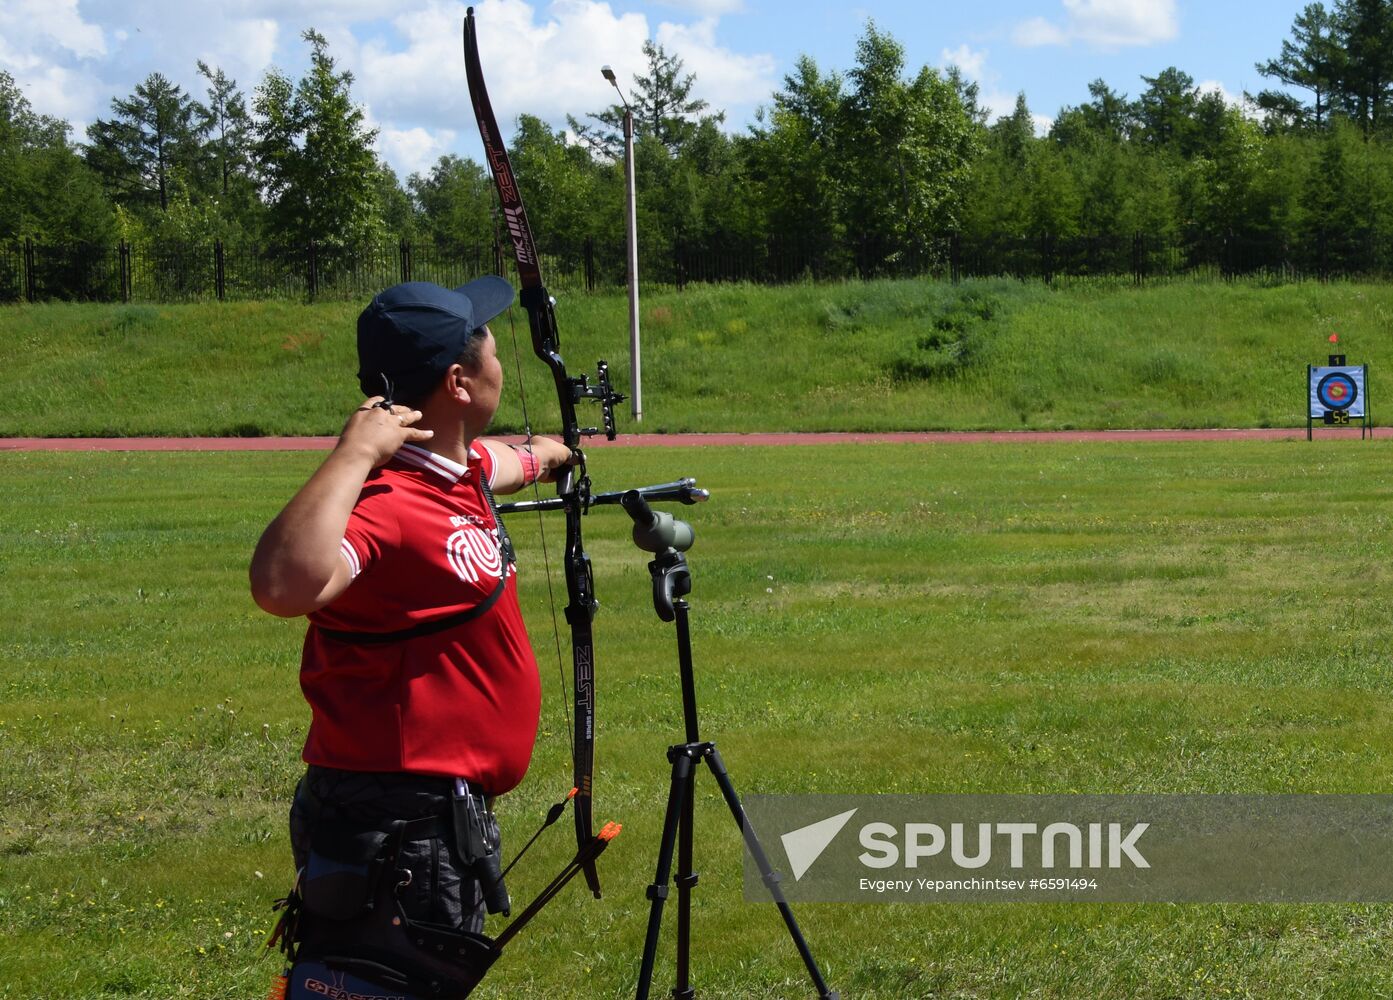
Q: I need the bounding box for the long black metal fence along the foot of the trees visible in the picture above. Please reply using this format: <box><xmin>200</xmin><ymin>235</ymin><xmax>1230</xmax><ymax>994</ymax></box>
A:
<box><xmin>0</xmin><ymin>230</ymin><xmax>1393</xmax><ymax>302</ymax></box>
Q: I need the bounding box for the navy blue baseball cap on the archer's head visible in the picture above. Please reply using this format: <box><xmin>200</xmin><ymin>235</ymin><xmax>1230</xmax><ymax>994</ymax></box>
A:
<box><xmin>358</xmin><ymin>274</ymin><xmax>513</xmax><ymax>400</ymax></box>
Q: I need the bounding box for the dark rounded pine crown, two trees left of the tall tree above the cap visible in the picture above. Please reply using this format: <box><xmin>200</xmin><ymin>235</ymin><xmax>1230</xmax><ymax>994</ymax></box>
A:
<box><xmin>86</xmin><ymin>72</ymin><xmax>199</xmax><ymax>212</ymax></box>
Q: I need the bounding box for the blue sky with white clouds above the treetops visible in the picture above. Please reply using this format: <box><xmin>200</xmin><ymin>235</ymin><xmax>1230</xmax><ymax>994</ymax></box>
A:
<box><xmin>0</xmin><ymin>0</ymin><xmax>1307</xmax><ymax>177</ymax></box>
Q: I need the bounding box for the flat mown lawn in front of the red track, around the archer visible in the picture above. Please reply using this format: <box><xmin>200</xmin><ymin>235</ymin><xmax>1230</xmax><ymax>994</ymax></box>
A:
<box><xmin>8</xmin><ymin>442</ymin><xmax>1393</xmax><ymax>1000</ymax></box>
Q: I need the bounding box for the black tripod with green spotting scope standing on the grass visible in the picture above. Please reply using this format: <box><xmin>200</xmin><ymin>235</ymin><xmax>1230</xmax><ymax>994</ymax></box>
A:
<box><xmin>621</xmin><ymin>490</ymin><xmax>837</xmax><ymax>1000</ymax></box>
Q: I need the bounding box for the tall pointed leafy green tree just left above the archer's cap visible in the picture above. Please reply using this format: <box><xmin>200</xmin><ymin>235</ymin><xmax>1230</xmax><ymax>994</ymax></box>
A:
<box><xmin>252</xmin><ymin>28</ymin><xmax>383</xmax><ymax>248</ymax></box>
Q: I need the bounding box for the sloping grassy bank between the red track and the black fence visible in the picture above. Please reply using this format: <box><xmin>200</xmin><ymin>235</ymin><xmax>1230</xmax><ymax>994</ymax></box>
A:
<box><xmin>8</xmin><ymin>280</ymin><xmax>1393</xmax><ymax>436</ymax></box>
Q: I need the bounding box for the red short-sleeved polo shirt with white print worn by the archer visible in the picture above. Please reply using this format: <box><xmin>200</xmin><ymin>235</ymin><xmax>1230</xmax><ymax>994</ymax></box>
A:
<box><xmin>299</xmin><ymin>444</ymin><xmax>542</xmax><ymax>795</ymax></box>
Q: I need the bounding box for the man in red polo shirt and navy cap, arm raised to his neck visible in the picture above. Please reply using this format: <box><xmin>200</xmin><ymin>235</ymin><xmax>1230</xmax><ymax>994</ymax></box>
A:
<box><xmin>251</xmin><ymin>276</ymin><xmax>576</xmax><ymax>996</ymax></box>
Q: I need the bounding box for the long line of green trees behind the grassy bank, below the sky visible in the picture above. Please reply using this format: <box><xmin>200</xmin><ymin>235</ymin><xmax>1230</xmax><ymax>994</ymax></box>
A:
<box><xmin>8</xmin><ymin>0</ymin><xmax>1393</xmax><ymax>298</ymax></box>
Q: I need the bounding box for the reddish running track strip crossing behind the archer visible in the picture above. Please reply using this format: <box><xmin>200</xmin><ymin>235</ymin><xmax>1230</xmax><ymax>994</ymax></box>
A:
<box><xmin>0</xmin><ymin>428</ymin><xmax>1393</xmax><ymax>451</ymax></box>
